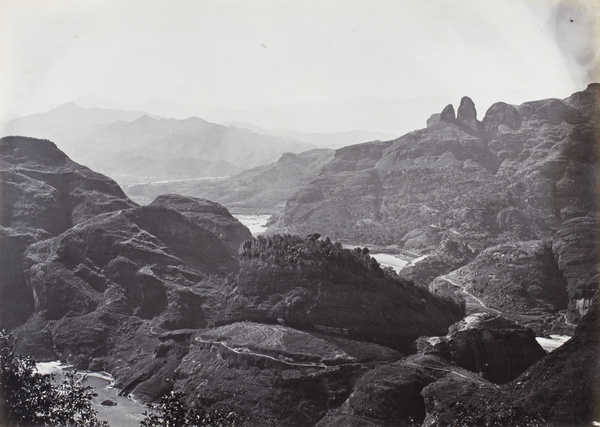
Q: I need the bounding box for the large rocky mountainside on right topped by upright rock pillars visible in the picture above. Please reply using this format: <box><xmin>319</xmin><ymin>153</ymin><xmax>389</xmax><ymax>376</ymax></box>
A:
<box><xmin>272</xmin><ymin>85</ymin><xmax>600</xmax><ymax>246</ymax></box>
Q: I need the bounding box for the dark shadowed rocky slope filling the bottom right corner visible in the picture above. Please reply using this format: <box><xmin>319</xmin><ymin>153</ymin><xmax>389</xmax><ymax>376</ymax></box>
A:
<box><xmin>423</xmin><ymin>303</ymin><xmax>600</xmax><ymax>426</ymax></box>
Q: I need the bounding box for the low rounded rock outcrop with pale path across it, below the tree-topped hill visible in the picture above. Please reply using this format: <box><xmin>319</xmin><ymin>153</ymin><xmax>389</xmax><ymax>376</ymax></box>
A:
<box><xmin>175</xmin><ymin>322</ymin><xmax>400</xmax><ymax>426</ymax></box>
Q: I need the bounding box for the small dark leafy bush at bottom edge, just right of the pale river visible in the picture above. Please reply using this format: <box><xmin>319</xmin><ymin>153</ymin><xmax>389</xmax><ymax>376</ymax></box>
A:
<box><xmin>140</xmin><ymin>392</ymin><xmax>246</xmax><ymax>427</ymax></box>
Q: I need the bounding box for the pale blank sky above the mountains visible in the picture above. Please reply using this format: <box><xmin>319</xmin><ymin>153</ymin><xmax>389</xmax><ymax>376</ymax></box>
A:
<box><xmin>0</xmin><ymin>0</ymin><xmax>600</xmax><ymax>130</ymax></box>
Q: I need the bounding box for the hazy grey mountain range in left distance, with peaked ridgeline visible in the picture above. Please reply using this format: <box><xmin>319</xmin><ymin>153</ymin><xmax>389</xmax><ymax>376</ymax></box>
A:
<box><xmin>2</xmin><ymin>103</ymin><xmax>313</xmax><ymax>183</ymax></box>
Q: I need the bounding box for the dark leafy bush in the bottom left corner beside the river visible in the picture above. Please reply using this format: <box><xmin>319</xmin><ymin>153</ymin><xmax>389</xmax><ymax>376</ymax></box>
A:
<box><xmin>0</xmin><ymin>329</ymin><xmax>108</xmax><ymax>427</ymax></box>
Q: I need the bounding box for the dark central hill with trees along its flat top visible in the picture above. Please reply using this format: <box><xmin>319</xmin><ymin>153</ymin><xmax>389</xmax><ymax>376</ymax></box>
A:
<box><xmin>225</xmin><ymin>235</ymin><xmax>462</xmax><ymax>349</ymax></box>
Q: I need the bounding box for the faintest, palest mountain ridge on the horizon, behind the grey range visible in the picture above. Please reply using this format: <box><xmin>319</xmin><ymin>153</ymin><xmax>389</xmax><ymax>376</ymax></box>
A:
<box><xmin>75</xmin><ymin>96</ymin><xmax>452</xmax><ymax>136</ymax></box>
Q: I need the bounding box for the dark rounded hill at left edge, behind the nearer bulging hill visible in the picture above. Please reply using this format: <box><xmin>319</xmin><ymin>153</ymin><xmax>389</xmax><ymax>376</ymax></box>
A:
<box><xmin>0</xmin><ymin>137</ymin><xmax>136</xmax><ymax>327</ymax></box>
